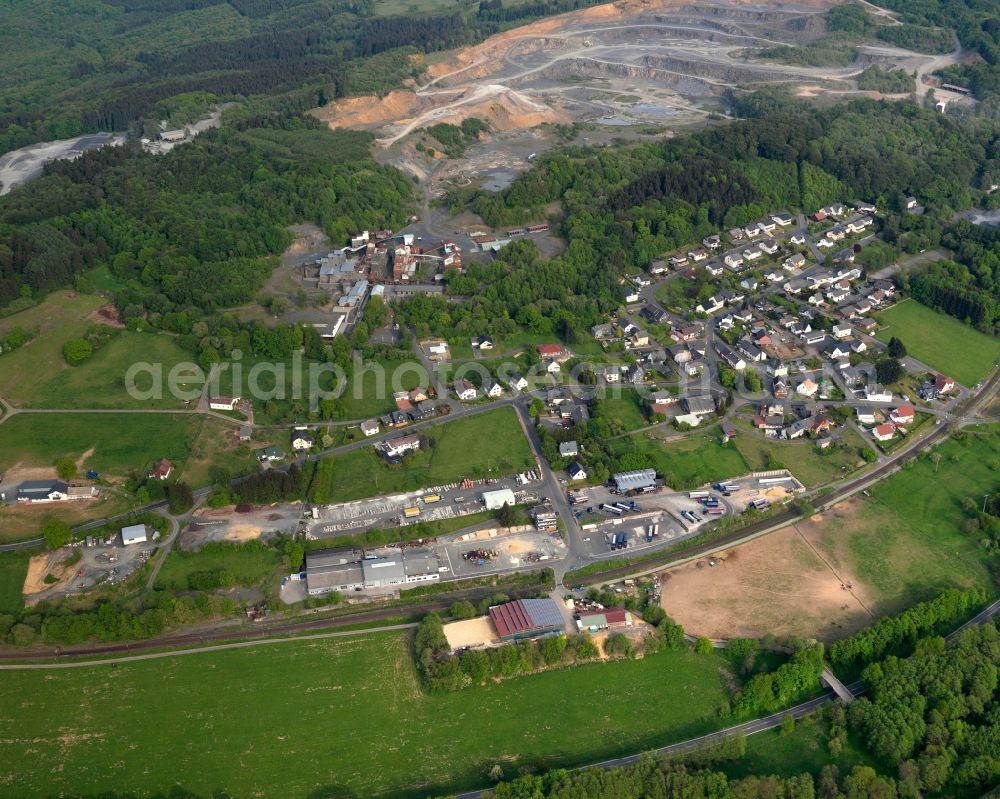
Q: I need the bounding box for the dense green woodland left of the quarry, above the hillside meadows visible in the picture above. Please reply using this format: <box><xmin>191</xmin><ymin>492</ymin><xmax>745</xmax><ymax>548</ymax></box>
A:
<box><xmin>0</xmin><ymin>115</ymin><xmax>412</xmax><ymax>315</ymax></box>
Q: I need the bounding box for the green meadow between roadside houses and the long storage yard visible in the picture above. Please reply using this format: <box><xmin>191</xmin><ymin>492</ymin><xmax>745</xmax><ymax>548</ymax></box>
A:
<box><xmin>314</xmin><ymin>408</ymin><xmax>534</xmax><ymax>502</ymax></box>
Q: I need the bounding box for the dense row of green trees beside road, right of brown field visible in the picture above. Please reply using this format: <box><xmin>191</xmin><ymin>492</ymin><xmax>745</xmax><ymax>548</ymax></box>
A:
<box><xmin>830</xmin><ymin>588</ymin><xmax>986</xmax><ymax>678</ymax></box>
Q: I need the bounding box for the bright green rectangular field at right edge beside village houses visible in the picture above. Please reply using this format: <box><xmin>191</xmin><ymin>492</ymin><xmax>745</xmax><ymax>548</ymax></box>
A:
<box><xmin>875</xmin><ymin>300</ymin><xmax>1000</xmax><ymax>386</ymax></box>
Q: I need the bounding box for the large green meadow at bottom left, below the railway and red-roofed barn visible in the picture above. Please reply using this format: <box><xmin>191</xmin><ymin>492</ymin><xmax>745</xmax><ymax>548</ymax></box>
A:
<box><xmin>0</xmin><ymin>633</ymin><xmax>727</xmax><ymax>799</ymax></box>
